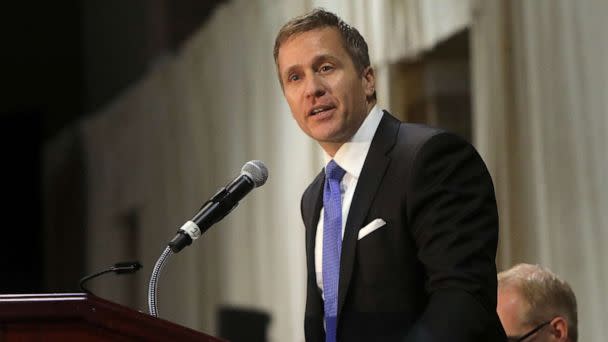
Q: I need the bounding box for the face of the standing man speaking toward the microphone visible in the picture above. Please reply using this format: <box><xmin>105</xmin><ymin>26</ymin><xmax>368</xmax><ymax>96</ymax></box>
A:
<box><xmin>277</xmin><ymin>27</ymin><xmax>375</xmax><ymax>156</ymax></box>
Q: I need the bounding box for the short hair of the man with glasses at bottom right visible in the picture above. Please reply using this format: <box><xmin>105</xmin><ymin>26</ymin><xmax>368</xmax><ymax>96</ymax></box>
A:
<box><xmin>498</xmin><ymin>264</ymin><xmax>578</xmax><ymax>342</ymax></box>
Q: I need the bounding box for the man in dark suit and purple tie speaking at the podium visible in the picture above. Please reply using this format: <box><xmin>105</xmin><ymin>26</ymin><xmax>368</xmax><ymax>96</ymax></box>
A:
<box><xmin>274</xmin><ymin>9</ymin><xmax>505</xmax><ymax>342</ymax></box>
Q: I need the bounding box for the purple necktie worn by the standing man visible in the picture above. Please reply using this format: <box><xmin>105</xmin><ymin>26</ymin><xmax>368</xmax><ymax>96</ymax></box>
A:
<box><xmin>323</xmin><ymin>160</ymin><xmax>346</xmax><ymax>342</ymax></box>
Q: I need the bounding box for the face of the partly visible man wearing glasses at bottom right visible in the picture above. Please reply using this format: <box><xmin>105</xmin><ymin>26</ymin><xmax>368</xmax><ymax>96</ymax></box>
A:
<box><xmin>496</xmin><ymin>287</ymin><xmax>561</xmax><ymax>342</ymax></box>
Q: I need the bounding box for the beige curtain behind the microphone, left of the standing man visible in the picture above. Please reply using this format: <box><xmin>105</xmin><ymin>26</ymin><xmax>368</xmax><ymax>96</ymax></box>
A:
<box><xmin>83</xmin><ymin>1</ymin><xmax>320</xmax><ymax>341</ymax></box>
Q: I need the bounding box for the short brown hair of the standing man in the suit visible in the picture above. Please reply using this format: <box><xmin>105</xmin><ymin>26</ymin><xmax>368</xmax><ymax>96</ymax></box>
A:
<box><xmin>274</xmin><ymin>8</ymin><xmax>370</xmax><ymax>73</ymax></box>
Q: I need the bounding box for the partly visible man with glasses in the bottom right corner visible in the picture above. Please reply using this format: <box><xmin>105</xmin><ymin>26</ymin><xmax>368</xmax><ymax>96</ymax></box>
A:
<box><xmin>497</xmin><ymin>264</ymin><xmax>578</xmax><ymax>342</ymax></box>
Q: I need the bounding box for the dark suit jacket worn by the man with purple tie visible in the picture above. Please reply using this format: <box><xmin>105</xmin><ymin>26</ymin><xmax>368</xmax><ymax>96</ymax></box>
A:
<box><xmin>301</xmin><ymin>112</ymin><xmax>506</xmax><ymax>342</ymax></box>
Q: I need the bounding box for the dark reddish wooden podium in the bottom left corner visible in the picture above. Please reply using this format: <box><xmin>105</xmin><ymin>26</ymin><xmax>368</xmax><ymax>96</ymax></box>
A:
<box><xmin>0</xmin><ymin>293</ymin><xmax>223</xmax><ymax>342</ymax></box>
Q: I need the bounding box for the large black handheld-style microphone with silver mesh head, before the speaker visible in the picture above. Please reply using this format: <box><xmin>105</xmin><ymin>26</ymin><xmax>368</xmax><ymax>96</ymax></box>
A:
<box><xmin>169</xmin><ymin>160</ymin><xmax>268</xmax><ymax>253</ymax></box>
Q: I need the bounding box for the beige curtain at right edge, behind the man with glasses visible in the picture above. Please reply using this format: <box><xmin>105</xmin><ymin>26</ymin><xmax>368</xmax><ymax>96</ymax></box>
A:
<box><xmin>472</xmin><ymin>0</ymin><xmax>608</xmax><ymax>342</ymax></box>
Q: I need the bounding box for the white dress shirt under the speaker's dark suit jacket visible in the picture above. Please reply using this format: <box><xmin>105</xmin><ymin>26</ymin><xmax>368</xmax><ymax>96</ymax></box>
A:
<box><xmin>315</xmin><ymin>105</ymin><xmax>383</xmax><ymax>293</ymax></box>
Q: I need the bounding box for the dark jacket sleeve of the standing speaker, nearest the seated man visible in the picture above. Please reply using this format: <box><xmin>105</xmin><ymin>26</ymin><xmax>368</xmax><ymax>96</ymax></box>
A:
<box><xmin>406</xmin><ymin>133</ymin><xmax>505</xmax><ymax>341</ymax></box>
